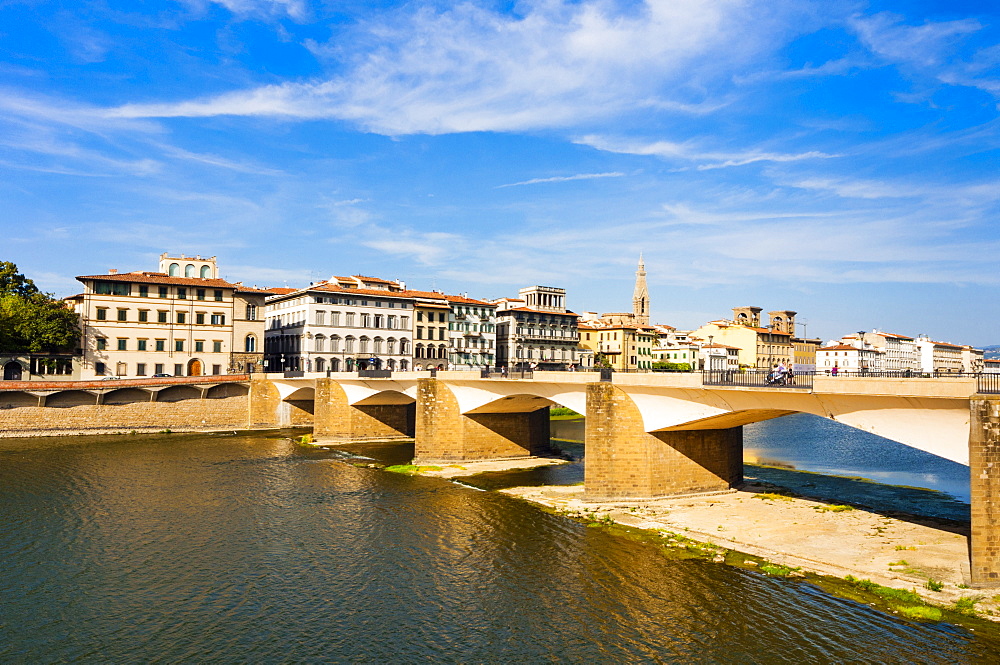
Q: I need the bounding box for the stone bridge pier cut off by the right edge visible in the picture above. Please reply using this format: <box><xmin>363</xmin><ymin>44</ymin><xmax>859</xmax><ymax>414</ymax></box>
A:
<box><xmin>969</xmin><ymin>395</ymin><xmax>1000</xmax><ymax>588</ymax></box>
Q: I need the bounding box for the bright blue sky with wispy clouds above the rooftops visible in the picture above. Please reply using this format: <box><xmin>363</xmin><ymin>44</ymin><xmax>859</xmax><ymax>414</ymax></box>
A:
<box><xmin>0</xmin><ymin>0</ymin><xmax>1000</xmax><ymax>345</ymax></box>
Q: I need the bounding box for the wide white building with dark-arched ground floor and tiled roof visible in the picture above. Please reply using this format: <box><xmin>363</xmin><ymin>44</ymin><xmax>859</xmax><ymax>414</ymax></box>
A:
<box><xmin>265</xmin><ymin>275</ymin><xmax>412</xmax><ymax>372</ymax></box>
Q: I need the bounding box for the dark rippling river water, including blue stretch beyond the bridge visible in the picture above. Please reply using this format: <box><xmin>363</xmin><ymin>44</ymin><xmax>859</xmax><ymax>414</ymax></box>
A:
<box><xmin>0</xmin><ymin>421</ymin><xmax>1000</xmax><ymax>664</ymax></box>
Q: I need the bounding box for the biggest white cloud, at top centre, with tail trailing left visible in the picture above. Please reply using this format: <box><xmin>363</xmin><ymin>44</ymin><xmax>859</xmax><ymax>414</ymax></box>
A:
<box><xmin>107</xmin><ymin>0</ymin><xmax>804</xmax><ymax>135</ymax></box>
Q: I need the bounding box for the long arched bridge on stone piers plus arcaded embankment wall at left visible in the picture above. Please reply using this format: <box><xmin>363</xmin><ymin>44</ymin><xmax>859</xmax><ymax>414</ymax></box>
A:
<box><xmin>0</xmin><ymin>371</ymin><xmax>1000</xmax><ymax>587</ymax></box>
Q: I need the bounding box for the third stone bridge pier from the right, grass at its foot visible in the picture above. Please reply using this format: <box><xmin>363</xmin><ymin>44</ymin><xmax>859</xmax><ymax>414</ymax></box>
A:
<box><xmin>413</xmin><ymin>379</ymin><xmax>549</xmax><ymax>464</ymax></box>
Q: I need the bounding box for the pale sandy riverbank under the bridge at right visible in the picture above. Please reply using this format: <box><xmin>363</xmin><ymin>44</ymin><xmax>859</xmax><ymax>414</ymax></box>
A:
<box><xmin>500</xmin><ymin>484</ymin><xmax>1000</xmax><ymax>620</ymax></box>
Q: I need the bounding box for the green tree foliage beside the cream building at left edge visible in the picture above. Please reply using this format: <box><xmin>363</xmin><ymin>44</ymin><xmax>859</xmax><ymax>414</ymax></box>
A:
<box><xmin>0</xmin><ymin>261</ymin><xmax>80</xmax><ymax>353</ymax></box>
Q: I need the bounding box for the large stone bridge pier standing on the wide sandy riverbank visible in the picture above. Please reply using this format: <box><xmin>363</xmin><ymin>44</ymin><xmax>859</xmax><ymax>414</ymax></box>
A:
<box><xmin>584</xmin><ymin>383</ymin><xmax>743</xmax><ymax>501</ymax></box>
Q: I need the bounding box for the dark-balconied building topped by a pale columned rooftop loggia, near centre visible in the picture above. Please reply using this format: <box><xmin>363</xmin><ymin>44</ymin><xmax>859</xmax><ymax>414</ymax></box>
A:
<box><xmin>492</xmin><ymin>286</ymin><xmax>583</xmax><ymax>369</ymax></box>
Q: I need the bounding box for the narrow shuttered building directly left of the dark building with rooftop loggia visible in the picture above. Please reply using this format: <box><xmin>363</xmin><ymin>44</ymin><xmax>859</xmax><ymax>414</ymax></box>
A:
<box><xmin>445</xmin><ymin>295</ymin><xmax>497</xmax><ymax>369</ymax></box>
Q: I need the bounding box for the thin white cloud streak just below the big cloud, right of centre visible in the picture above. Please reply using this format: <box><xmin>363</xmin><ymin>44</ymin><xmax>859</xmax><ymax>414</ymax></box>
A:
<box><xmin>576</xmin><ymin>135</ymin><xmax>839</xmax><ymax>171</ymax></box>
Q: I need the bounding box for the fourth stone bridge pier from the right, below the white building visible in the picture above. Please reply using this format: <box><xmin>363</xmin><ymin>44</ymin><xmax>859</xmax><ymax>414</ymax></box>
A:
<box><xmin>313</xmin><ymin>379</ymin><xmax>415</xmax><ymax>441</ymax></box>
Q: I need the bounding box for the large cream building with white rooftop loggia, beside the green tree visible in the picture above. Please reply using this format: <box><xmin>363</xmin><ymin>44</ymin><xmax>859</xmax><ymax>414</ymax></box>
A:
<box><xmin>66</xmin><ymin>254</ymin><xmax>269</xmax><ymax>379</ymax></box>
